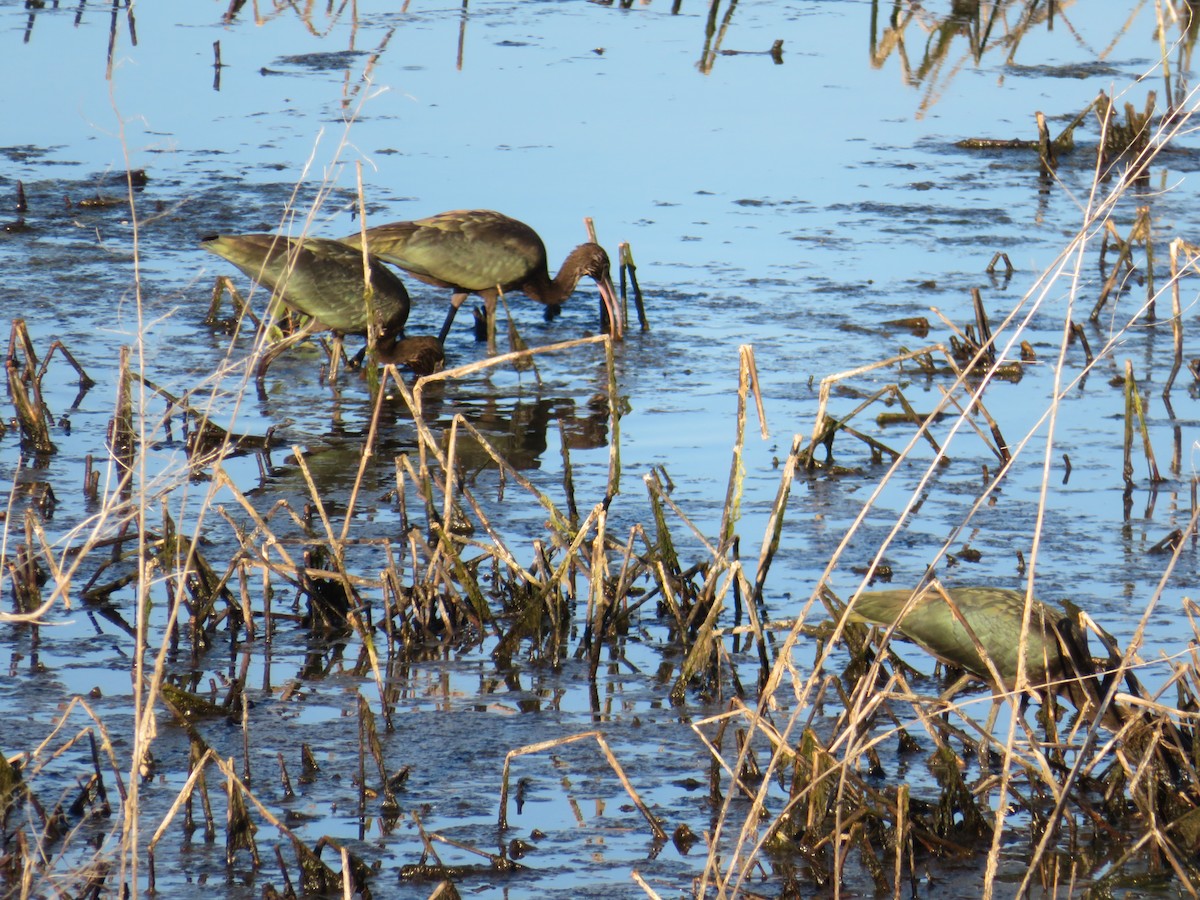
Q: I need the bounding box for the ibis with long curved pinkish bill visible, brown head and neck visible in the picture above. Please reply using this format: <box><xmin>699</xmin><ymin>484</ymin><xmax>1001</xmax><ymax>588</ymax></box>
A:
<box><xmin>343</xmin><ymin>209</ymin><xmax>624</xmax><ymax>342</ymax></box>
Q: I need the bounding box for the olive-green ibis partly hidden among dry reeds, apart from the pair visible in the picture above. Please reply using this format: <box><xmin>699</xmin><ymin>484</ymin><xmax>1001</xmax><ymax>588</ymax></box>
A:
<box><xmin>848</xmin><ymin>586</ymin><xmax>1114</xmax><ymax>724</ymax></box>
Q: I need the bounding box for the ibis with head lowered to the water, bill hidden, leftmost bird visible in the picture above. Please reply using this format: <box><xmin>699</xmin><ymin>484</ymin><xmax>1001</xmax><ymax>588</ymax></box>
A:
<box><xmin>200</xmin><ymin>234</ymin><xmax>442</xmax><ymax>378</ymax></box>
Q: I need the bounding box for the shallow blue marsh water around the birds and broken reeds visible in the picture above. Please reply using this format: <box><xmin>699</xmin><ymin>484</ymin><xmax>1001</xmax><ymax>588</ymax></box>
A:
<box><xmin>0</xmin><ymin>0</ymin><xmax>1200</xmax><ymax>896</ymax></box>
